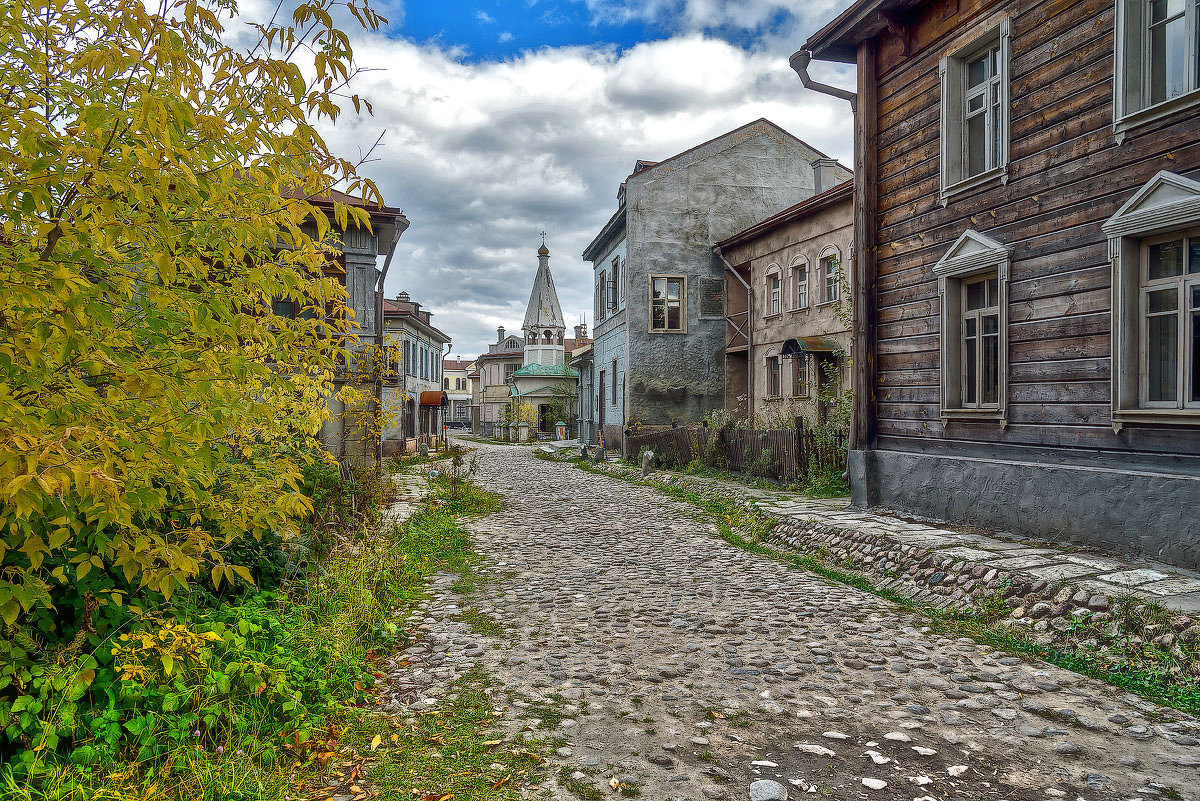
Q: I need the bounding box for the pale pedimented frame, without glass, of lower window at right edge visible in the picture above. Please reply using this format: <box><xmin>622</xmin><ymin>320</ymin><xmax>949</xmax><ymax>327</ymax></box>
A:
<box><xmin>1100</xmin><ymin>170</ymin><xmax>1200</xmax><ymax>433</ymax></box>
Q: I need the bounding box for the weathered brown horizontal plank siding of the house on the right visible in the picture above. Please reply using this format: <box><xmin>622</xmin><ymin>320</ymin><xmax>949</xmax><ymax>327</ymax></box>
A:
<box><xmin>875</xmin><ymin>0</ymin><xmax>1200</xmax><ymax>453</ymax></box>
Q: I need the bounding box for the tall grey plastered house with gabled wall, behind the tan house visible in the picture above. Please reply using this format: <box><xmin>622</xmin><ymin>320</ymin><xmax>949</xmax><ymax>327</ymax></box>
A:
<box><xmin>583</xmin><ymin>120</ymin><xmax>851</xmax><ymax>447</ymax></box>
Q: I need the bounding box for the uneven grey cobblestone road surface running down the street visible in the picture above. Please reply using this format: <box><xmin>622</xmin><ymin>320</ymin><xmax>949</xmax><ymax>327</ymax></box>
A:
<box><xmin>379</xmin><ymin>445</ymin><xmax>1200</xmax><ymax>801</ymax></box>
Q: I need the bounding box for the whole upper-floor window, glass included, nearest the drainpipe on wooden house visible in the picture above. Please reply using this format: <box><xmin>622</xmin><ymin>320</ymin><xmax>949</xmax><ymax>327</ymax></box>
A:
<box><xmin>938</xmin><ymin>18</ymin><xmax>1010</xmax><ymax>205</ymax></box>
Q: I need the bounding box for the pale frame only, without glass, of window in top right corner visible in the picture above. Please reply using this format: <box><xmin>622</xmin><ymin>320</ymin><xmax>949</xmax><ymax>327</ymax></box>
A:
<box><xmin>1112</xmin><ymin>0</ymin><xmax>1200</xmax><ymax>138</ymax></box>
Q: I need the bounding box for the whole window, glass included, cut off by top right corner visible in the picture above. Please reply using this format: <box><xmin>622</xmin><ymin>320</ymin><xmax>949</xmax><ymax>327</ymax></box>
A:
<box><xmin>1112</xmin><ymin>0</ymin><xmax>1200</xmax><ymax>134</ymax></box>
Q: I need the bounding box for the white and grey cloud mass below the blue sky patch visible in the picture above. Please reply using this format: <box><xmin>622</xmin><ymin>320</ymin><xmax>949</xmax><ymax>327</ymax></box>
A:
<box><xmin>307</xmin><ymin>21</ymin><xmax>852</xmax><ymax>357</ymax></box>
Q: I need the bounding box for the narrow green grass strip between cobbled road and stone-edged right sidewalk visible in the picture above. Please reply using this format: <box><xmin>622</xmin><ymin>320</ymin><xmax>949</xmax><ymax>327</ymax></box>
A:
<box><xmin>552</xmin><ymin>454</ymin><xmax>1200</xmax><ymax>713</ymax></box>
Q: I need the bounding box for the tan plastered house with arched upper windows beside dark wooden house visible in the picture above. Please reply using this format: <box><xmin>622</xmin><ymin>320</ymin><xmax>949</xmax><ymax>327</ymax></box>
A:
<box><xmin>714</xmin><ymin>173</ymin><xmax>854</xmax><ymax>423</ymax></box>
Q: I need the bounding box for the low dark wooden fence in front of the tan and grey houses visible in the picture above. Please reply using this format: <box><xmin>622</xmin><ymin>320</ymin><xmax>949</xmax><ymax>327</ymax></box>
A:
<box><xmin>625</xmin><ymin>424</ymin><xmax>847</xmax><ymax>483</ymax></box>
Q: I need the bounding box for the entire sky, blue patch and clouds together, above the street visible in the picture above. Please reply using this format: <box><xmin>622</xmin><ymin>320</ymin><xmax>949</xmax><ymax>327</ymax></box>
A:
<box><xmin>268</xmin><ymin>0</ymin><xmax>853</xmax><ymax>357</ymax></box>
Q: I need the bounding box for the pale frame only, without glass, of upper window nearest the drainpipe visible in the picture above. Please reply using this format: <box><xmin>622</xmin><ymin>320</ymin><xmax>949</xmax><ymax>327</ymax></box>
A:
<box><xmin>937</xmin><ymin>16</ymin><xmax>1012</xmax><ymax>206</ymax></box>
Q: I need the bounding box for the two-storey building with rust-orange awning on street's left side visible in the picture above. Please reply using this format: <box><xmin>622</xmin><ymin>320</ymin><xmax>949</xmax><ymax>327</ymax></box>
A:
<box><xmin>383</xmin><ymin>293</ymin><xmax>450</xmax><ymax>456</ymax></box>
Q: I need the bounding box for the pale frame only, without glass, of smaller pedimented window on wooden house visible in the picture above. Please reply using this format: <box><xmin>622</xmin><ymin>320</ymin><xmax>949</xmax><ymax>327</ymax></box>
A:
<box><xmin>934</xmin><ymin>230</ymin><xmax>1013</xmax><ymax>428</ymax></box>
